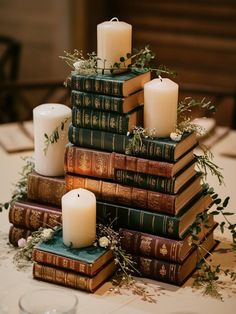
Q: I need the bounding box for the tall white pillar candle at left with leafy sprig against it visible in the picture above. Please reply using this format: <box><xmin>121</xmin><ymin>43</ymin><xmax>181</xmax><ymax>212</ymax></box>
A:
<box><xmin>33</xmin><ymin>103</ymin><xmax>71</xmax><ymax>176</ymax></box>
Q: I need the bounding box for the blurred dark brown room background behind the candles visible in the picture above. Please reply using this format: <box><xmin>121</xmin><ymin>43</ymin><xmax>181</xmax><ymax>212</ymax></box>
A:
<box><xmin>0</xmin><ymin>0</ymin><xmax>236</xmax><ymax>128</ymax></box>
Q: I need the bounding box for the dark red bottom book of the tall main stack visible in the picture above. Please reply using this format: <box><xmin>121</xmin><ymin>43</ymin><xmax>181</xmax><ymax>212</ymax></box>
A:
<box><xmin>134</xmin><ymin>227</ymin><xmax>217</xmax><ymax>286</ymax></box>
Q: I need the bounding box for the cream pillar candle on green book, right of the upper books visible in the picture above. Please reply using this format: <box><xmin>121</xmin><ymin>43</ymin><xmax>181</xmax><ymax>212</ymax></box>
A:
<box><xmin>144</xmin><ymin>78</ymin><xmax>179</xmax><ymax>137</ymax></box>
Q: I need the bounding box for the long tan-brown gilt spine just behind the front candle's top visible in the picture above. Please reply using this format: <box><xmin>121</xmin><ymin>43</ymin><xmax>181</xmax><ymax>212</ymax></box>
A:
<box><xmin>66</xmin><ymin>175</ymin><xmax>176</xmax><ymax>215</ymax></box>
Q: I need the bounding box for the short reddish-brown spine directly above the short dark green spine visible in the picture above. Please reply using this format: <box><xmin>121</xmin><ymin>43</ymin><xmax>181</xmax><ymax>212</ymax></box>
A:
<box><xmin>114</xmin><ymin>153</ymin><xmax>173</xmax><ymax>177</ymax></box>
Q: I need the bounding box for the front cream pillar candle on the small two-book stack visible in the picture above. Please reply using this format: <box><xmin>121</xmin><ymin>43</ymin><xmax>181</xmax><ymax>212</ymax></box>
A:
<box><xmin>62</xmin><ymin>189</ymin><xmax>96</xmax><ymax>248</ymax></box>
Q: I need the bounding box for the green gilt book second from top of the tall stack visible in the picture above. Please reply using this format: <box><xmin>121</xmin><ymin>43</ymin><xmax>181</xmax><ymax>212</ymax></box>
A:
<box><xmin>71</xmin><ymin>90</ymin><xmax>144</xmax><ymax>113</ymax></box>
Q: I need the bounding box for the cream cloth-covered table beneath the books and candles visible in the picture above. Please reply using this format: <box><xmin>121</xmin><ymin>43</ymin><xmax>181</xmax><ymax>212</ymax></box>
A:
<box><xmin>0</xmin><ymin>131</ymin><xmax>236</xmax><ymax>314</ymax></box>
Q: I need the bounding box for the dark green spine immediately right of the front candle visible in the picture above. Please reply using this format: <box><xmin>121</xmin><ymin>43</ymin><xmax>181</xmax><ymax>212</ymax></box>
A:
<box><xmin>97</xmin><ymin>201</ymin><xmax>180</xmax><ymax>239</ymax></box>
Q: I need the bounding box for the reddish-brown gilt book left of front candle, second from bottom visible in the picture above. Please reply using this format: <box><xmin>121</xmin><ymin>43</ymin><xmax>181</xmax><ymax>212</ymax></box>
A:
<box><xmin>9</xmin><ymin>201</ymin><xmax>61</xmax><ymax>230</ymax></box>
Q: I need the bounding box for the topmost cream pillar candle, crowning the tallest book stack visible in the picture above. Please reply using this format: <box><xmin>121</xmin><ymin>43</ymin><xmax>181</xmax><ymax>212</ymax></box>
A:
<box><xmin>97</xmin><ymin>18</ymin><xmax>132</xmax><ymax>68</ymax></box>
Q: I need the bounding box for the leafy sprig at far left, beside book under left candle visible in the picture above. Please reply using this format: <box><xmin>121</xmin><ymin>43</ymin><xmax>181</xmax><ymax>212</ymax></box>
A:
<box><xmin>0</xmin><ymin>157</ymin><xmax>34</xmax><ymax>212</ymax></box>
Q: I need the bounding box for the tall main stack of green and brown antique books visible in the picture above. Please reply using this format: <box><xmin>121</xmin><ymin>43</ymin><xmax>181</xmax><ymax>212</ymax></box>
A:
<box><xmin>65</xmin><ymin>73</ymin><xmax>215</xmax><ymax>285</ymax></box>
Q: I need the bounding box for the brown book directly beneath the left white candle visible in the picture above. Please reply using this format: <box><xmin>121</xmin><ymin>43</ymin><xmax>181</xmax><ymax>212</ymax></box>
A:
<box><xmin>27</xmin><ymin>171</ymin><xmax>66</xmax><ymax>207</ymax></box>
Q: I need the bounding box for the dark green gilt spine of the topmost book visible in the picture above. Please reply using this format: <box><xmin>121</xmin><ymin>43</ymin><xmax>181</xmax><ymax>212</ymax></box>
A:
<box><xmin>71</xmin><ymin>75</ymin><xmax>123</xmax><ymax>97</ymax></box>
